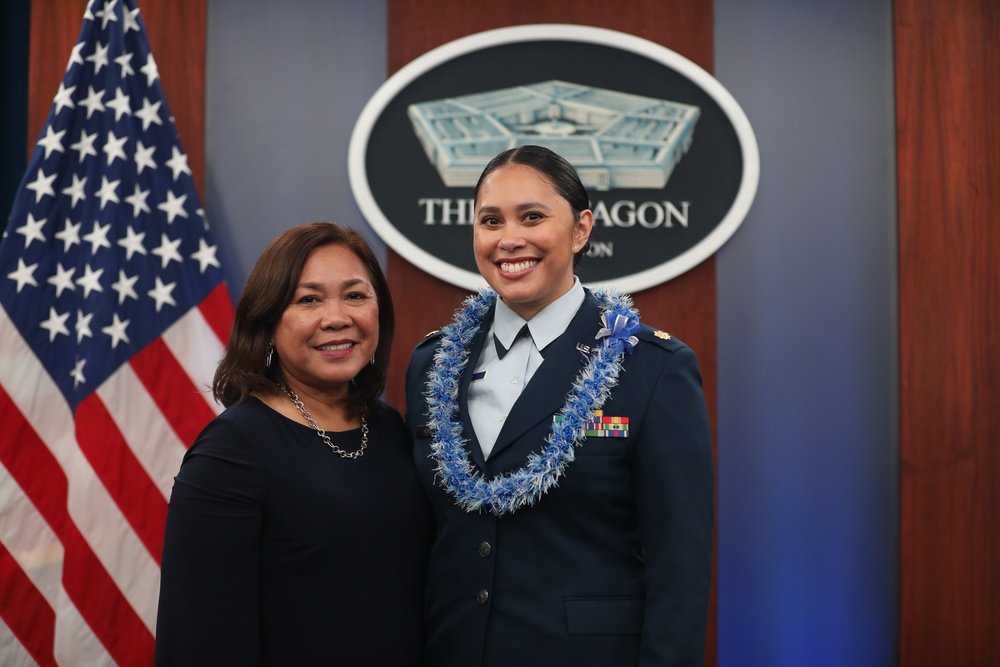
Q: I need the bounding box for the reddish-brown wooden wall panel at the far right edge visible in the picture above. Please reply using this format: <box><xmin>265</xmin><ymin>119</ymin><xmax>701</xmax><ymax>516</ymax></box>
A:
<box><xmin>894</xmin><ymin>0</ymin><xmax>1000</xmax><ymax>667</ymax></box>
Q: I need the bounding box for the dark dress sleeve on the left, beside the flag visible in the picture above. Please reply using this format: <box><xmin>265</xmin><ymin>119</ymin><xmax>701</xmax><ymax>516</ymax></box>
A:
<box><xmin>155</xmin><ymin>418</ymin><xmax>265</xmax><ymax>667</ymax></box>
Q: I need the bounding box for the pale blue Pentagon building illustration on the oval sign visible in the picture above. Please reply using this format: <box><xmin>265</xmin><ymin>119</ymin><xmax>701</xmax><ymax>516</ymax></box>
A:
<box><xmin>407</xmin><ymin>81</ymin><xmax>701</xmax><ymax>190</ymax></box>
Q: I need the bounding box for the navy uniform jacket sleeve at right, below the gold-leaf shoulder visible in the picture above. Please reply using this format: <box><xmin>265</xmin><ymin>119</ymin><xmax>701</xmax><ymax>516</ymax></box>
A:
<box><xmin>633</xmin><ymin>346</ymin><xmax>714</xmax><ymax>667</ymax></box>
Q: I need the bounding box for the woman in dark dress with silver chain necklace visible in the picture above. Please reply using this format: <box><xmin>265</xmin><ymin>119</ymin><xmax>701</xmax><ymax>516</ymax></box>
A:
<box><xmin>156</xmin><ymin>223</ymin><xmax>431</xmax><ymax>667</ymax></box>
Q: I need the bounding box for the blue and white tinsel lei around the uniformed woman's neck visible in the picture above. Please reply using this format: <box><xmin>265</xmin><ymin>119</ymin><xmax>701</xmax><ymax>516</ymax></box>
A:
<box><xmin>424</xmin><ymin>289</ymin><xmax>639</xmax><ymax>516</ymax></box>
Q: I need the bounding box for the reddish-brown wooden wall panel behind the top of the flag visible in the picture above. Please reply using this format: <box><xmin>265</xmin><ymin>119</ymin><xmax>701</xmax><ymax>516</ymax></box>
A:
<box><xmin>28</xmin><ymin>0</ymin><xmax>205</xmax><ymax>201</ymax></box>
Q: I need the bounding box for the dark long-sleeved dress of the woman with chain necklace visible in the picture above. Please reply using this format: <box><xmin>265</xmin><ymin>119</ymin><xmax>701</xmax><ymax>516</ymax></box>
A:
<box><xmin>156</xmin><ymin>399</ymin><xmax>432</xmax><ymax>667</ymax></box>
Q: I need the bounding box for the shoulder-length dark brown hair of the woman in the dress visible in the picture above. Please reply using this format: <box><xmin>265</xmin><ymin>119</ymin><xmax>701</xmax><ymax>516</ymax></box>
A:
<box><xmin>212</xmin><ymin>222</ymin><xmax>396</xmax><ymax>415</ymax></box>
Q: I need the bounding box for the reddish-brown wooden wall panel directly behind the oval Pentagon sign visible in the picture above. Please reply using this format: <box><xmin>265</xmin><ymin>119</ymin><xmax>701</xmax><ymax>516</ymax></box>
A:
<box><xmin>388</xmin><ymin>0</ymin><xmax>717</xmax><ymax>665</ymax></box>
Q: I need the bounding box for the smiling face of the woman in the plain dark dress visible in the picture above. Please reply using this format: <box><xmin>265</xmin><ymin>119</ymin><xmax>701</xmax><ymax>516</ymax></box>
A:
<box><xmin>274</xmin><ymin>245</ymin><xmax>379</xmax><ymax>396</ymax></box>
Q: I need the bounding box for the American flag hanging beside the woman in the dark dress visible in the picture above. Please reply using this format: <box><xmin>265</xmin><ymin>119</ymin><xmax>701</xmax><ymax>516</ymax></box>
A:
<box><xmin>0</xmin><ymin>0</ymin><xmax>232</xmax><ymax>667</ymax></box>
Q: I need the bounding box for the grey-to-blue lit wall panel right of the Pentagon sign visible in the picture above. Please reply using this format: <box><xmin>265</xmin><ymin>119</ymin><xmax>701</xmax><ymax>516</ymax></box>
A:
<box><xmin>714</xmin><ymin>0</ymin><xmax>899</xmax><ymax>667</ymax></box>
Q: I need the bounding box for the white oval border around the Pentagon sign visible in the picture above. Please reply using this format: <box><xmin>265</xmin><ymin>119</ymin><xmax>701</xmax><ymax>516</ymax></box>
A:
<box><xmin>347</xmin><ymin>23</ymin><xmax>760</xmax><ymax>292</ymax></box>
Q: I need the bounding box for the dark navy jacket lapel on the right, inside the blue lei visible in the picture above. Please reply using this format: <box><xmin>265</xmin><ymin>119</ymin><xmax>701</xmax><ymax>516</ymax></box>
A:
<box><xmin>490</xmin><ymin>290</ymin><xmax>601</xmax><ymax>465</ymax></box>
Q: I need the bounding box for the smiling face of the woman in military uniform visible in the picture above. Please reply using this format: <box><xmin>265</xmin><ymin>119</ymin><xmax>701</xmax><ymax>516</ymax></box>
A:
<box><xmin>473</xmin><ymin>164</ymin><xmax>594</xmax><ymax>320</ymax></box>
